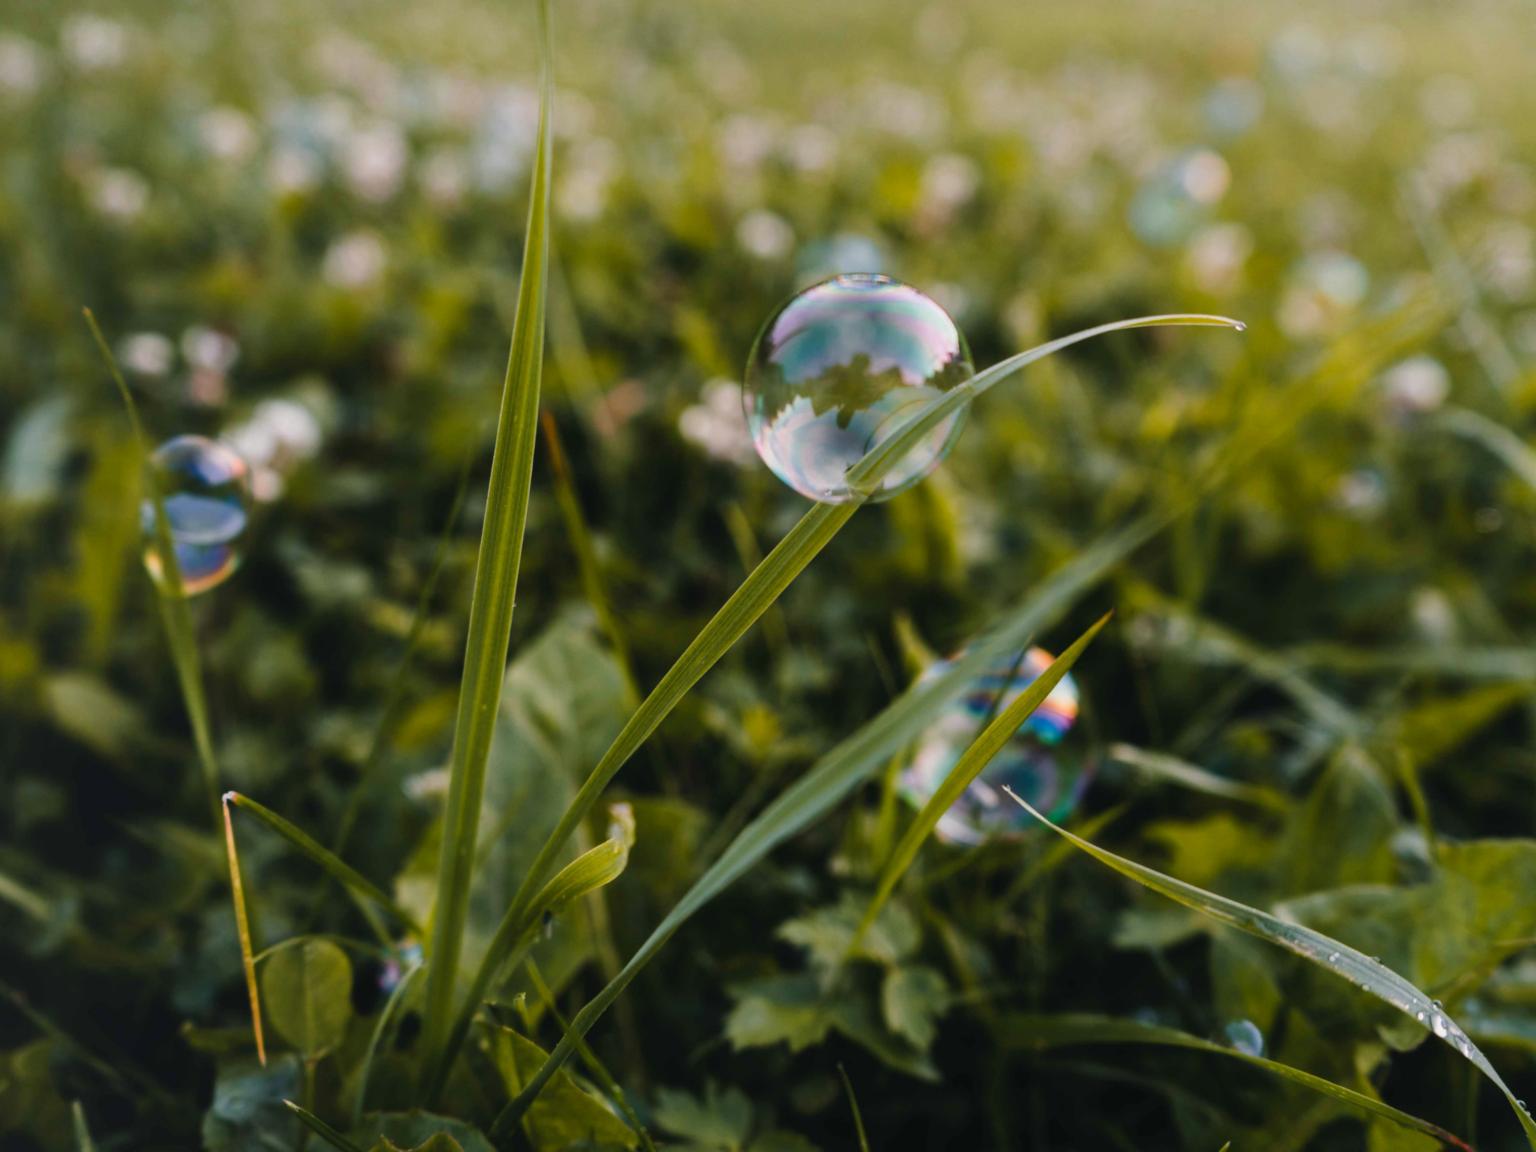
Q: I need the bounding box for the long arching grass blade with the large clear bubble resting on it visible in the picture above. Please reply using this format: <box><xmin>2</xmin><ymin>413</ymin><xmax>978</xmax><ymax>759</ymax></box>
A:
<box><xmin>429</xmin><ymin>315</ymin><xmax>1243</xmax><ymax>1097</ymax></box>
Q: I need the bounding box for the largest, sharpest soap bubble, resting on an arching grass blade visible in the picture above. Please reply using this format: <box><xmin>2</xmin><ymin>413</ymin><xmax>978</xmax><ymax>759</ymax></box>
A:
<box><xmin>742</xmin><ymin>273</ymin><xmax>974</xmax><ymax>504</ymax></box>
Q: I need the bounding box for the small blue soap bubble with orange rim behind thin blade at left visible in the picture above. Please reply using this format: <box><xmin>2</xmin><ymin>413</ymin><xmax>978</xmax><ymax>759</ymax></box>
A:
<box><xmin>140</xmin><ymin>436</ymin><xmax>250</xmax><ymax>596</ymax></box>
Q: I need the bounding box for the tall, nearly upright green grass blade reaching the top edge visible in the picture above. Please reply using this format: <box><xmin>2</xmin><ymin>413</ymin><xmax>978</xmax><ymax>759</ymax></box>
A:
<box><xmin>421</xmin><ymin>0</ymin><xmax>553</xmax><ymax>1083</ymax></box>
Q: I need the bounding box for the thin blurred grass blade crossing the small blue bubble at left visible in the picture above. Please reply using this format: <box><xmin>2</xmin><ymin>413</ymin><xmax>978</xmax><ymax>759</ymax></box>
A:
<box><xmin>81</xmin><ymin>309</ymin><xmax>221</xmax><ymax>829</ymax></box>
